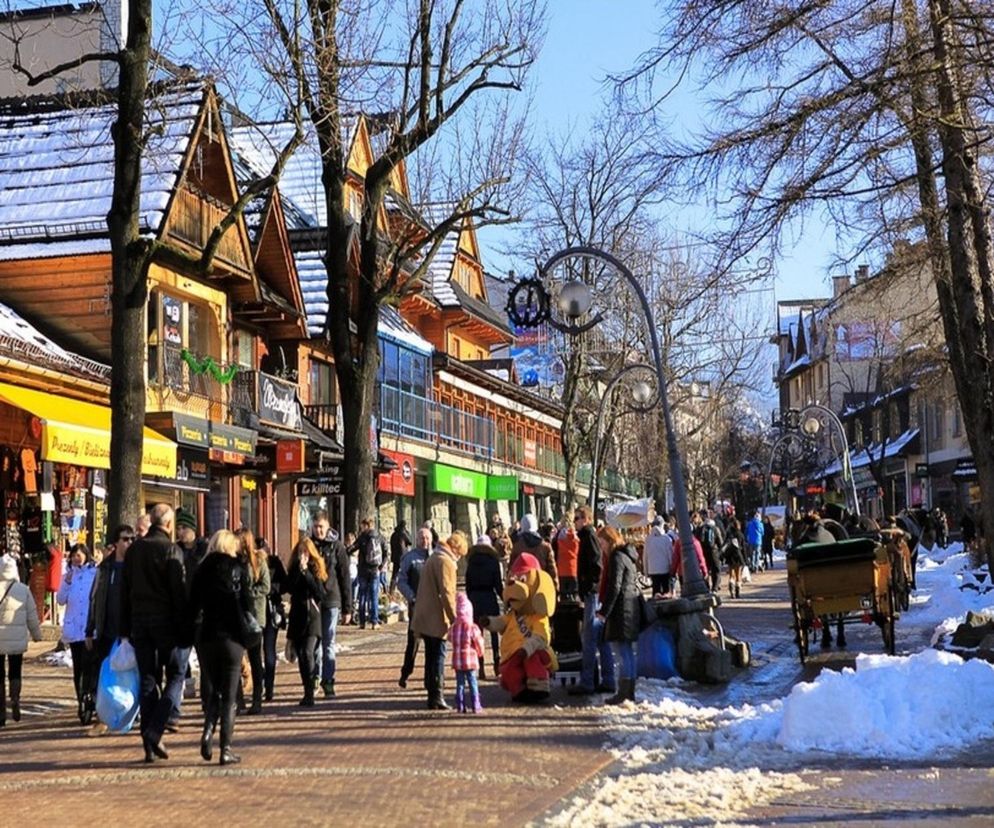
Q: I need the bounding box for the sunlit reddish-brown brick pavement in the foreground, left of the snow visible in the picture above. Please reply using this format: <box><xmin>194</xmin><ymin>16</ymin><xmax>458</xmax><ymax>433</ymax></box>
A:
<box><xmin>0</xmin><ymin>624</ymin><xmax>611</xmax><ymax>826</ymax></box>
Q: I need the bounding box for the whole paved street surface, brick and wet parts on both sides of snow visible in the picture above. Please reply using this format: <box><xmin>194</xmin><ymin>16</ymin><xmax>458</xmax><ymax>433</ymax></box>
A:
<box><xmin>7</xmin><ymin>564</ymin><xmax>994</xmax><ymax>826</ymax></box>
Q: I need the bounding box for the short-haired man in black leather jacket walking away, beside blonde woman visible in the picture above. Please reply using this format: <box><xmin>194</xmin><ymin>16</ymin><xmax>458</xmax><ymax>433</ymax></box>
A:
<box><xmin>120</xmin><ymin>503</ymin><xmax>186</xmax><ymax>762</ymax></box>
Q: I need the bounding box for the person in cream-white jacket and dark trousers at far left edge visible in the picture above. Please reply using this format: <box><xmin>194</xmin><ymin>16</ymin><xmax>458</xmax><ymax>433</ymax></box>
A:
<box><xmin>0</xmin><ymin>555</ymin><xmax>41</xmax><ymax>727</ymax></box>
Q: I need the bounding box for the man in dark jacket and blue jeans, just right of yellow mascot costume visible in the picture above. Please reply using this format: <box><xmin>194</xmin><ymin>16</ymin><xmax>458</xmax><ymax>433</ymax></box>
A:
<box><xmin>569</xmin><ymin>506</ymin><xmax>617</xmax><ymax>696</ymax></box>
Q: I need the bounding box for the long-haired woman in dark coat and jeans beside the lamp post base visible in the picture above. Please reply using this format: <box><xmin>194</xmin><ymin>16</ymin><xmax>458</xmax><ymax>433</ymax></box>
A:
<box><xmin>599</xmin><ymin>543</ymin><xmax>642</xmax><ymax>704</ymax></box>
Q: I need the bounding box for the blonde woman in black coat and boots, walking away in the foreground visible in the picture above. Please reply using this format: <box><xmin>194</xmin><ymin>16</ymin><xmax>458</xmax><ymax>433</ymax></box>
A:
<box><xmin>190</xmin><ymin>529</ymin><xmax>252</xmax><ymax>765</ymax></box>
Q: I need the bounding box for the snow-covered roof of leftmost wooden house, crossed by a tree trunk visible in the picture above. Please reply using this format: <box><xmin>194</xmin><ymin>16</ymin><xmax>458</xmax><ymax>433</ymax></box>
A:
<box><xmin>0</xmin><ymin>84</ymin><xmax>204</xmax><ymax>258</ymax></box>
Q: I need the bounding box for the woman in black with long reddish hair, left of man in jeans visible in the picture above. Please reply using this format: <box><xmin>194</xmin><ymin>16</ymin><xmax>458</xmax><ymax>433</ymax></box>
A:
<box><xmin>286</xmin><ymin>538</ymin><xmax>328</xmax><ymax>707</ymax></box>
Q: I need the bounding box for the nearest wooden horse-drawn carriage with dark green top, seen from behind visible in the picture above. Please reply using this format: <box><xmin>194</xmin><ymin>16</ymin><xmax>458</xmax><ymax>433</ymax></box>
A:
<box><xmin>787</xmin><ymin>537</ymin><xmax>899</xmax><ymax>664</ymax></box>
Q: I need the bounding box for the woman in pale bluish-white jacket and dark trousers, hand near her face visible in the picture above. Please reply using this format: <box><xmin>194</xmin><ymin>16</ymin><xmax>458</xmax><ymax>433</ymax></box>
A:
<box><xmin>56</xmin><ymin>543</ymin><xmax>97</xmax><ymax>724</ymax></box>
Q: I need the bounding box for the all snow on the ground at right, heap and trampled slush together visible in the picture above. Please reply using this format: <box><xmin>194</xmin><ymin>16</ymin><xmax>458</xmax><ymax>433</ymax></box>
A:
<box><xmin>550</xmin><ymin>545</ymin><xmax>994</xmax><ymax>826</ymax></box>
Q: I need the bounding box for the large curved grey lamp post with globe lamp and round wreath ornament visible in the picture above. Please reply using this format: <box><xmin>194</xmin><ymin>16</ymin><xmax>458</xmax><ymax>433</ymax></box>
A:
<box><xmin>507</xmin><ymin>246</ymin><xmax>710</xmax><ymax>597</ymax></box>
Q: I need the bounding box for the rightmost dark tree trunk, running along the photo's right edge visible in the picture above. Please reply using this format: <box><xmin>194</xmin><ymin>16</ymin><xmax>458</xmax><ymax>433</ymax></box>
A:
<box><xmin>929</xmin><ymin>0</ymin><xmax>994</xmax><ymax>567</ymax></box>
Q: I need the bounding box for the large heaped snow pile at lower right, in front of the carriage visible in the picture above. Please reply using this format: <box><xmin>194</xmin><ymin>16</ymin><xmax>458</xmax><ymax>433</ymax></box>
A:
<box><xmin>777</xmin><ymin>650</ymin><xmax>994</xmax><ymax>758</ymax></box>
